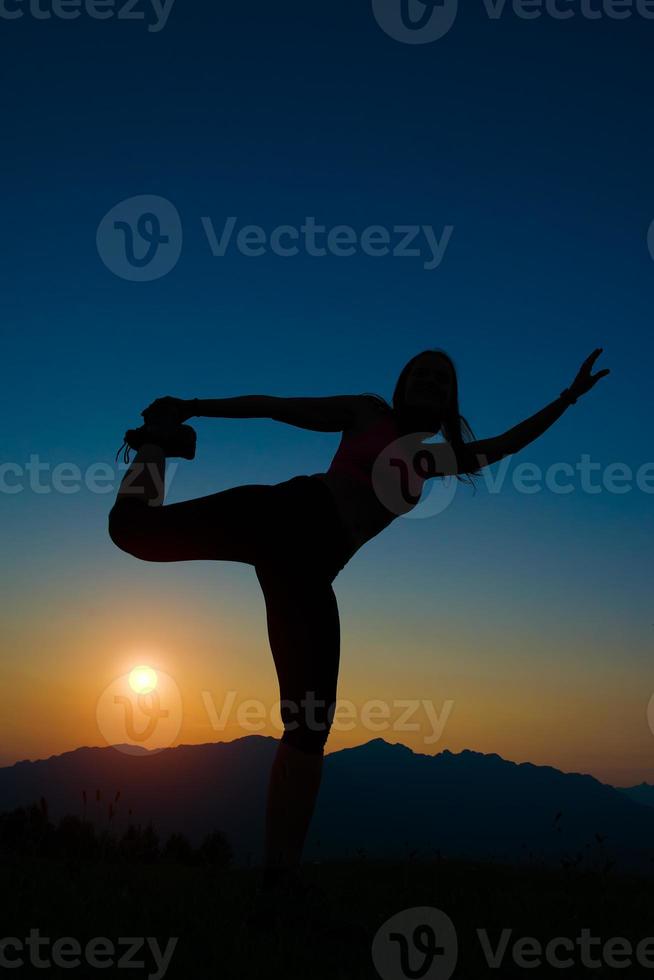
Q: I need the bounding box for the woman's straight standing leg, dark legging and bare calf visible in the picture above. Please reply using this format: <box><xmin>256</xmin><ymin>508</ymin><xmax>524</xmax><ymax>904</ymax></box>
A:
<box><xmin>256</xmin><ymin>565</ymin><xmax>340</xmax><ymax>886</ymax></box>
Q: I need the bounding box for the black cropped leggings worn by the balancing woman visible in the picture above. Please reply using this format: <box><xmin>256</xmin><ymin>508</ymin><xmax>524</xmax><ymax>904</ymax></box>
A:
<box><xmin>109</xmin><ymin>476</ymin><xmax>356</xmax><ymax>753</ymax></box>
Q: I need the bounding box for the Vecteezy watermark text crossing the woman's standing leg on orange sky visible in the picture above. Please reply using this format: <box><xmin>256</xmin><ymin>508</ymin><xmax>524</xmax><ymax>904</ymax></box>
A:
<box><xmin>202</xmin><ymin>691</ymin><xmax>454</xmax><ymax>745</ymax></box>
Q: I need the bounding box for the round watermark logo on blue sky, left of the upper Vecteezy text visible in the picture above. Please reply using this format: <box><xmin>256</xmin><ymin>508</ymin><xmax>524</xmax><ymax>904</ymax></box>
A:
<box><xmin>96</xmin><ymin>194</ymin><xmax>183</xmax><ymax>282</ymax></box>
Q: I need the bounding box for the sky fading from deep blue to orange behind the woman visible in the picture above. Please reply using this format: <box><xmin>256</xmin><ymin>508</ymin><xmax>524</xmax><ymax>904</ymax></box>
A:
<box><xmin>0</xmin><ymin>0</ymin><xmax>654</xmax><ymax>785</ymax></box>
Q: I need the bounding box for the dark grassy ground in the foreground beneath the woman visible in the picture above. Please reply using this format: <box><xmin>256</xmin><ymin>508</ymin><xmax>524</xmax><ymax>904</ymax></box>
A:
<box><xmin>0</xmin><ymin>854</ymin><xmax>654</xmax><ymax>980</ymax></box>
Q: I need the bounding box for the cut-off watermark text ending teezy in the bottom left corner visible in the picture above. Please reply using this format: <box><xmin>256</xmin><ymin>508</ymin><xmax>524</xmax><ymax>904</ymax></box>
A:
<box><xmin>0</xmin><ymin>929</ymin><xmax>179</xmax><ymax>980</ymax></box>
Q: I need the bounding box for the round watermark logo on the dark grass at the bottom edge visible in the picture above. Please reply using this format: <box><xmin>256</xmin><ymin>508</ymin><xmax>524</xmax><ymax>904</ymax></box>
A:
<box><xmin>372</xmin><ymin>906</ymin><xmax>459</xmax><ymax>980</ymax></box>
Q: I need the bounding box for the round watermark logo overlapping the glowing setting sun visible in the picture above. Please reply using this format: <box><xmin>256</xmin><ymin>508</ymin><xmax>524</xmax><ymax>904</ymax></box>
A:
<box><xmin>96</xmin><ymin>664</ymin><xmax>183</xmax><ymax>755</ymax></box>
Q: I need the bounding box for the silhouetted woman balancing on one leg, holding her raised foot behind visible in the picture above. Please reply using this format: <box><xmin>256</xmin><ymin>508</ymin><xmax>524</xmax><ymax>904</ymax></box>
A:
<box><xmin>109</xmin><ymin>348</ymin><xmax>609</xmax><ymax>920</ymax></box>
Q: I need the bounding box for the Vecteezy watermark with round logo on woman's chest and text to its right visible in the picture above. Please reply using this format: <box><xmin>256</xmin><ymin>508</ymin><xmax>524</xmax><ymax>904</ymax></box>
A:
<box><xmin>372</xmin><ymin>432</ymin><xmax>654</xmax><ymax>519</ymax></box>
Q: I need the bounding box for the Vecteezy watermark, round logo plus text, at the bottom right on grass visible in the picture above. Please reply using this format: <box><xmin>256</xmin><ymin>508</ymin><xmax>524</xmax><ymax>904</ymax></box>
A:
<box><xmin>372</xmin><ymin>907</ymin><xmax>654</xmax><ymax>980</ymax></box>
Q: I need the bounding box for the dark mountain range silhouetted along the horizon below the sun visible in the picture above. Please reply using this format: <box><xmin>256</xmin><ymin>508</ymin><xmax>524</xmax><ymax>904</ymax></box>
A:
<box><xmin>0</xmin><ymin>735</ymin><xmax>654</xmax><ymax>873</ymax></box>
